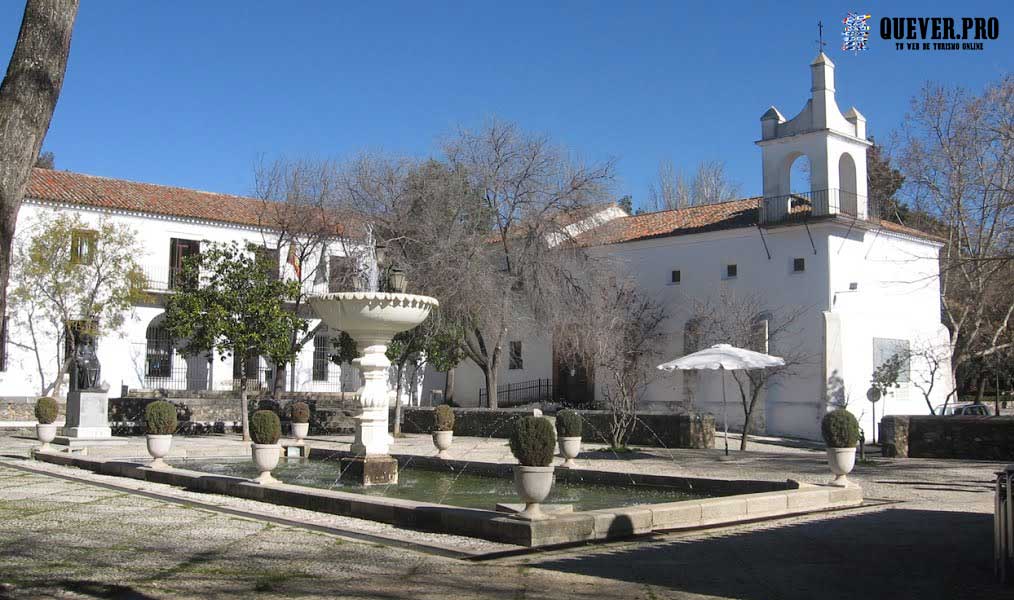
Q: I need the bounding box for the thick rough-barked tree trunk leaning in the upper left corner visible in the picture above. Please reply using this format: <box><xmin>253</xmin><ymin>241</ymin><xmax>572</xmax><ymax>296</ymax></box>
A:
<box><xmin>0</xmin><ymin>0</ymin><xmax>78</xmax><ymax>324</ymax></box>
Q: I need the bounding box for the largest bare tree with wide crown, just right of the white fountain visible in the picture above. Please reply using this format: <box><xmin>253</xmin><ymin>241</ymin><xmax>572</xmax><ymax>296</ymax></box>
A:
<box><xmin>336</xmin><ymin>121</ymin><xmax>612</xmax><ymax>407</ymax></box>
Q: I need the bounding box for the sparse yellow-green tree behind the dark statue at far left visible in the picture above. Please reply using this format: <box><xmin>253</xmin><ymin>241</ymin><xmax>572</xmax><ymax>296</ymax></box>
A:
<box><xmin>10</xmin><ymin>213</ymin><xmax>146</xmax><ymax>395</ymax></box>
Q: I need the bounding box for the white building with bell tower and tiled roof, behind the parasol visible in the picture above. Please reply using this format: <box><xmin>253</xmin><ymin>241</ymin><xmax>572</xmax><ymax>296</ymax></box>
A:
<box><xmin>440</xmin><ymin>53</ymin><xmax>950</xmax><ymax>439</ymax></box>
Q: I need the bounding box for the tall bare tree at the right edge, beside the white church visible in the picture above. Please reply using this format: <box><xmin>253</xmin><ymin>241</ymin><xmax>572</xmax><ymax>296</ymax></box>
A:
<box><xmin>900</xmin><ymin>75</ymin><xmax>1014</xmax><ymax>399</ymax></box>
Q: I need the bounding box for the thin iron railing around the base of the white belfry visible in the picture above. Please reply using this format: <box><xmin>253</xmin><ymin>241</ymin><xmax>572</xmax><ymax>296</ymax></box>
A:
<box><xmin>758</xmin><ymin>188</ymin><xmax>880</xmax><ymax>225</ymax></box>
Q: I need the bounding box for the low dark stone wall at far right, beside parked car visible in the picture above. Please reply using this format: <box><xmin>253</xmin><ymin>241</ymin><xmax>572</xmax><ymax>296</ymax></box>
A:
<box><xmin>880</xmin><ymin>416</ymin><xmax>1014</xmax><ymax>460</ymax></box>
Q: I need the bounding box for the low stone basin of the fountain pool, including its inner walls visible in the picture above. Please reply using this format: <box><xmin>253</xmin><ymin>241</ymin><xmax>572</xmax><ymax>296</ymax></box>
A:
<box><xmin>35</xmin><ymin>450</ymin><xmax>863</xmax><ymax>547</ymax></box>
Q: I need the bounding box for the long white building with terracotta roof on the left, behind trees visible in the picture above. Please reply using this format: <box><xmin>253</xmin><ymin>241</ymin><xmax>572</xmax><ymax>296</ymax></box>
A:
<box><xmin>0</xmin><ymin>169</ymin><xmax>359</xmax><ymax>405</ymax></box>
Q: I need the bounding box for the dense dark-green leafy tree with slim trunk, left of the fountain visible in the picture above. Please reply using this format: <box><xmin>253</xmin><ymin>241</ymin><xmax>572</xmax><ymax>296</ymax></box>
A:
<box><xmin>165</xmin><ymin>242</ymin><xmax>306</xmax><ymax>440</ymax></box>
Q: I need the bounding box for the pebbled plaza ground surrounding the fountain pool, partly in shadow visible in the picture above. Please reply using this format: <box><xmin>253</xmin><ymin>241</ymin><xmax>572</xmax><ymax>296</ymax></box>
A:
<box><xmin>0</xmin><ymin>434</ymin><xmax>1014</xmax><ymax>600</ymax></box>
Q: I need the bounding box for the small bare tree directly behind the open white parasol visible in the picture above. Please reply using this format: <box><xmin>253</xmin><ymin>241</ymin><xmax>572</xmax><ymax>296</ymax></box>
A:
<box><xmin>692</xmin><ymin>292</ymin><xmax>811</xmax><ymax>450</ymax></box>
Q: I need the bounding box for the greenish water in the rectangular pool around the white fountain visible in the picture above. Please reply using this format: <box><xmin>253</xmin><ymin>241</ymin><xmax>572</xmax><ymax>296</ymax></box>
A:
<box><xmin>170</xmin><ymin>458</ymin><xmax>706</xmax><ymax>511</ymax></box>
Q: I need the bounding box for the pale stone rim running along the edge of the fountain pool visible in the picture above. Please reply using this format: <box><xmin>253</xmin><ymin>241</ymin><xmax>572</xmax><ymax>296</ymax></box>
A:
<box><xmin>32</xmin><ymin>452</ymin><xmax>863</xmax><ymax>547</ymax></box>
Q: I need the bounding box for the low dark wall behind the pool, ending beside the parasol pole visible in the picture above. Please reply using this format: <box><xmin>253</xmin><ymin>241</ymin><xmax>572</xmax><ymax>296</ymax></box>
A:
<box><xmin>391</xmin><ymin>407</ymin><xmax>715</xmax><ymax>448</ymax></box>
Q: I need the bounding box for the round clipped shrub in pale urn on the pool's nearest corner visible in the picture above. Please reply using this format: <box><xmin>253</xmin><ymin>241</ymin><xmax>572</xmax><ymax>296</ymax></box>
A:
<box><xmin>510</xmin><ymin>417</ymin><xmax>557</xmax><ymax>520</ymax></box>
